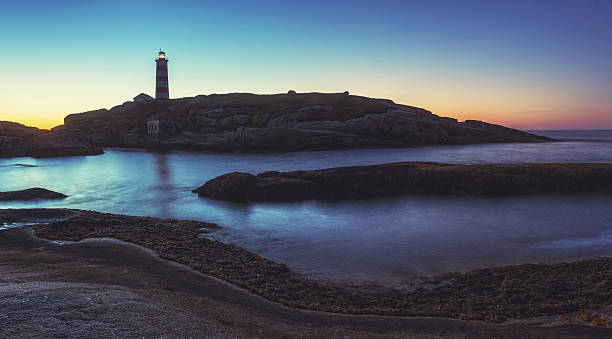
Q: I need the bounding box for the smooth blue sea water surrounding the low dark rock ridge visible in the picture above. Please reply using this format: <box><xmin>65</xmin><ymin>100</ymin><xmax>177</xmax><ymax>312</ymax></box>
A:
<box><xmin>0</xmin><ymin>131</ymin><xmax>612</xmax><ymax>283</ymax></box>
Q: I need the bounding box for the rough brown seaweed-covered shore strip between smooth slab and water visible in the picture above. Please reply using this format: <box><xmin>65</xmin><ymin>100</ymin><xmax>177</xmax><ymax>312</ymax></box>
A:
<box><xmin>29</xmin><ymin>211</ymin><xmax>612</xmax><ymax>327</ymax></box>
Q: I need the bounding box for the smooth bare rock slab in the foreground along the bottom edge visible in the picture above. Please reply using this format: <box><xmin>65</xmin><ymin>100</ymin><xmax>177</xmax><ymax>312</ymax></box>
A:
<box><xmin>0</xmin><ymin>224</ymin><xmax>610</xmax><ymax>339</ymax></box>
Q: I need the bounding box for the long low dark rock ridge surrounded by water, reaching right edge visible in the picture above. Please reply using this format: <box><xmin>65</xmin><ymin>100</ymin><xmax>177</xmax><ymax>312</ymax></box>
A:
<box><xmin>193</xmin><ymin>162</ymin><xmax>612</xmax><ymax>202</ymax></box>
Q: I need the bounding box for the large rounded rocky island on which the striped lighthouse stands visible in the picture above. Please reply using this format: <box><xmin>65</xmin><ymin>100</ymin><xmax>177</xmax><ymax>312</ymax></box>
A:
<box><xmin>64</xmin><ymin>93</ymin><xmax>551</xmax><ymax>152</ymax></box>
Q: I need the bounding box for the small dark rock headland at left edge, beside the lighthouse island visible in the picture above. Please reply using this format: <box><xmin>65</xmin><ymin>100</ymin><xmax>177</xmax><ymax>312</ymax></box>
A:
<box><xmin>0</xmin><ymin>121</ymin><xmax>103</xmax><ymax>158</ymax></box>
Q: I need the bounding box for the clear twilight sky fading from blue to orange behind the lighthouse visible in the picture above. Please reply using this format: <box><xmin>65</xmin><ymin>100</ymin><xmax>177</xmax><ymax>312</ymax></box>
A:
<box><xmin>0</xmin><ymin>0</ymin><xmax>612</xmax><ymax>129</ymax></box>
